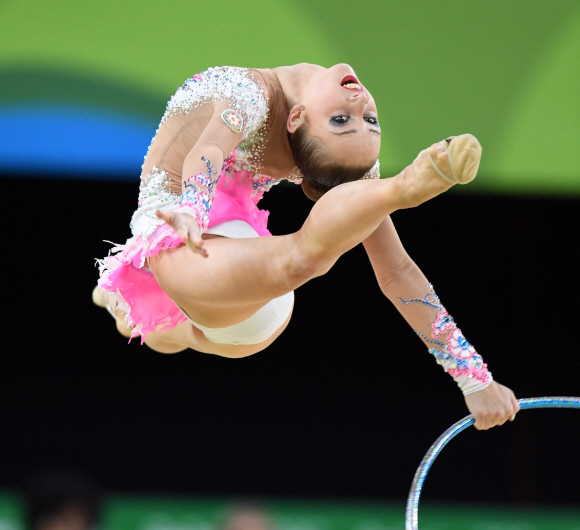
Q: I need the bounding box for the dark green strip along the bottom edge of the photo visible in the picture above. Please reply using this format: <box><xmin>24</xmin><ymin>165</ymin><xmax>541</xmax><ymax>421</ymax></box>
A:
<box><xmin>0</xmin><ymin>494</ymin><xmax>580</xmax><ymax>530</ymax></box>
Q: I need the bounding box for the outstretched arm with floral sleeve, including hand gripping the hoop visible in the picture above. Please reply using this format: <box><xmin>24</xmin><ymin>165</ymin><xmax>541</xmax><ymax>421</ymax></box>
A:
<box><xmin>363</xmin><ymin>217</ymin><xmax>519</xmax><ymax>429</ymax></box>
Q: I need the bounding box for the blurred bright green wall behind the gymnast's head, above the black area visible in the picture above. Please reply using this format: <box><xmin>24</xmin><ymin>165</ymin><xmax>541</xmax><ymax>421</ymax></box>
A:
<box><xmin>0</xmin><ymin>0</ymin><xmax>580</xmax><ymax>194</ymax></box>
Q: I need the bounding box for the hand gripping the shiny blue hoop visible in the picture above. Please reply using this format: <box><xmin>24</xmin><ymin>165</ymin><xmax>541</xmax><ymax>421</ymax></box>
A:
<box><xmin>465</xmin><ymin>381</ymin><xmax>520</xmax><ymax>430</ymax></box>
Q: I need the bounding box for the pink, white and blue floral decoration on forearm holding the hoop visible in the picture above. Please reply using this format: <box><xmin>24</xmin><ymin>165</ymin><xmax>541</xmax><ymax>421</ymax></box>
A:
<box><xmin>399</xmin><ymin>284</ymin><xmax>493</xmax><ymax>395</ymax></box>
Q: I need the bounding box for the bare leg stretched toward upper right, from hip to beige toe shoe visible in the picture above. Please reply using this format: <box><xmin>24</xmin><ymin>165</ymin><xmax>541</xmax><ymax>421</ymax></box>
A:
<box><xmin>150</xmin><ymin>144</ymin><xmax>450</xmax><ymax>327</ymax></box>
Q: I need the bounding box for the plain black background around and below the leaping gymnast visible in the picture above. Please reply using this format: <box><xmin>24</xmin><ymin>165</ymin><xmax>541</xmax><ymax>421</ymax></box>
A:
<box><xmin>0</xmin><ymin>175</ymin><xmax>580</xmax><ymax>504</ymax></box>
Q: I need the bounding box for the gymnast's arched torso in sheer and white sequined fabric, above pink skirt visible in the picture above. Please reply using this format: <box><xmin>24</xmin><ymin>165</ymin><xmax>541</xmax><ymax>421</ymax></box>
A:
<box><xmin>141</xmin><ymin>67</ymin><xmax>301</xmax><ymax>200</ymax></box>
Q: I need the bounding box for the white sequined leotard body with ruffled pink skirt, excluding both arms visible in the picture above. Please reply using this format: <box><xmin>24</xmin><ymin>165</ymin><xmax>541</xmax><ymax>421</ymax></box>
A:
<box><xmin>99</xmin><ymin>66</ymin><xmax>304</xmax><ymax>341</ymax></box>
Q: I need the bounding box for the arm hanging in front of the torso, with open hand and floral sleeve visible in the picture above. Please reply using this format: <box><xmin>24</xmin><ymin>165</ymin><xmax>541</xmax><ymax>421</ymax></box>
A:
<box><xmin>156</xmin><ymin>101</ymin><xmax>242</xmax><ymax>257</ymax></box>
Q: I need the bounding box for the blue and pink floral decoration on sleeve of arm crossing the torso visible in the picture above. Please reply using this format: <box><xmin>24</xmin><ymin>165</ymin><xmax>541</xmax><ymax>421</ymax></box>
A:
<box><xmin>177</xmin><ymin>156</ymin><xmax>219</xmax><ymax>232</ymax></box>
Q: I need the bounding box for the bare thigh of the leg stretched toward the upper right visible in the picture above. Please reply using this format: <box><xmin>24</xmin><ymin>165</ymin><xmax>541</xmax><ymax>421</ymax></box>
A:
<box><xmin>149</xmin><ymin>234</ymin><xmax>308</xmax><ymax>327</ymax></box>
